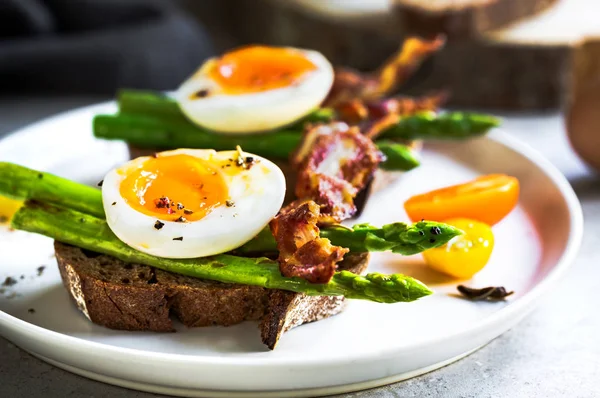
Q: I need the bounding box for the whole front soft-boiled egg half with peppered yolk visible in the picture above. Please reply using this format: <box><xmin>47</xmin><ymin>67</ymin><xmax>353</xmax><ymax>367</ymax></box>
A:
<box><xmin>102</xmin><ymin>148</ymin><xmax>285</xmax><ymax>258</ymax></box>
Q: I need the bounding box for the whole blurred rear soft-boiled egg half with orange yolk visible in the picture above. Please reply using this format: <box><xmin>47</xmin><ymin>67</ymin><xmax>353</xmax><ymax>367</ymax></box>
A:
<box><xmin>175</xmin><ymin>46</ymin><xmax>334</xmax><ymax>134</ymax></box>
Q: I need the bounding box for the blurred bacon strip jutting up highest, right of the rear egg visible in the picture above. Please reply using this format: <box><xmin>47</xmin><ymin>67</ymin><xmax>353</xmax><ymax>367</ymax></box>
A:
<box><xmin>324</xmin><ymin>35</ymin><xmax>446</xmax><ymax>107</ymax></box>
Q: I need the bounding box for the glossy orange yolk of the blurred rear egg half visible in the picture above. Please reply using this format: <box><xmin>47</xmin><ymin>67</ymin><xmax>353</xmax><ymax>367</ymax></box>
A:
<box><xmin>209</xmin><ymin>46</ymin><xmax>317</xmax><ymax>94</ymax></box>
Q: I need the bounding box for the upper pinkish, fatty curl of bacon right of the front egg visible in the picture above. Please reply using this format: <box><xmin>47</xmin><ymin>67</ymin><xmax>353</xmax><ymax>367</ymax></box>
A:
<box><xmin>291</xmin><ymin>122</ymin><xmax>383</xmax><ymax>223</ymax></box>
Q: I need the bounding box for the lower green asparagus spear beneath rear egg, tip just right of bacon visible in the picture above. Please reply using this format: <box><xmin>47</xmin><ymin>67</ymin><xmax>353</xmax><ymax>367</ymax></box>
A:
<box><xmin>93</xmin><ymin>114</ymin><xmax>418</xmax><ymax>170</ymax></box>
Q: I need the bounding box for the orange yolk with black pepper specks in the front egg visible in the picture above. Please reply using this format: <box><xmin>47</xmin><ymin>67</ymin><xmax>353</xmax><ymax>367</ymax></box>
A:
<box><xmin>119</xmin><ymin>154</ymin><xmax>229</xmax><ymax>222</ymax></box>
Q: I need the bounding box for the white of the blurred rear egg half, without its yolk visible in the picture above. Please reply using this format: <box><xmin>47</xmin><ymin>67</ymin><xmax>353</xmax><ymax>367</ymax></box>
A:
<box><xmin>175</xmin><ymin>48</ymin><xmax>334</xmax><ymax>134</ymax></box>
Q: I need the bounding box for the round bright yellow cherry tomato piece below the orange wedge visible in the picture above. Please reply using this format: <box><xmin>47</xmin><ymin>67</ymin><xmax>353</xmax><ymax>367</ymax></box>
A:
<box><xmin>423</xmin><ymin>218</ymin><xmax>494</xmax><ymax>279</ymax></box>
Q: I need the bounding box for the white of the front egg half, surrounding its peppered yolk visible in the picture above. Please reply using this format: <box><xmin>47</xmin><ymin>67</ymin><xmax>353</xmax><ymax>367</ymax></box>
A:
<box><xmin>102</xmin><ymin>149</ymin><xmax>285</xmax><ymax>258</ymax></box>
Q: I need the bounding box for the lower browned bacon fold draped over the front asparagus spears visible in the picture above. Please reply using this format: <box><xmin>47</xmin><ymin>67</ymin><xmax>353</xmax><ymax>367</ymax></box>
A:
<box><xmin>269</xmin><ymin>200</ymin><xmax>348</xmax><ymax>283</ymax></box>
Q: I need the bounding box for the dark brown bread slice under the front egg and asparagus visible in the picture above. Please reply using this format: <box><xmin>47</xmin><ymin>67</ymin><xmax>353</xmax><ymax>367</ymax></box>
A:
<box><xmin>54</xmin><ymin>242</ymin><xmax>369</xmax><ymax>349</ymax></box>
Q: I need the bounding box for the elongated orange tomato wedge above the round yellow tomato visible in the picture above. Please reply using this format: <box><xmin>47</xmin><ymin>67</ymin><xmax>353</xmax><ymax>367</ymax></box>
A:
<box><xmin>404</xmin><ymin>174</ymin><xmax>519</xmax><ymax>225</ymax></box>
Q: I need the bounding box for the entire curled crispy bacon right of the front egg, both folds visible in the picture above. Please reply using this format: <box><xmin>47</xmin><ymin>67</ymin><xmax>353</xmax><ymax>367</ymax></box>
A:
<box><xmin>269</xmin><ymin>122</ymin><xmax>383</xmax><ymax>283</ymax></box>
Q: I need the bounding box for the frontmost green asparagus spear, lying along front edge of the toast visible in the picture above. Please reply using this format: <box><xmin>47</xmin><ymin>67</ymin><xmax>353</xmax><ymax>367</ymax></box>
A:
<box><xmin>12</xmin><ymin>201</ymin><xmax>432</xmax><ymax>303</ymax></box>
